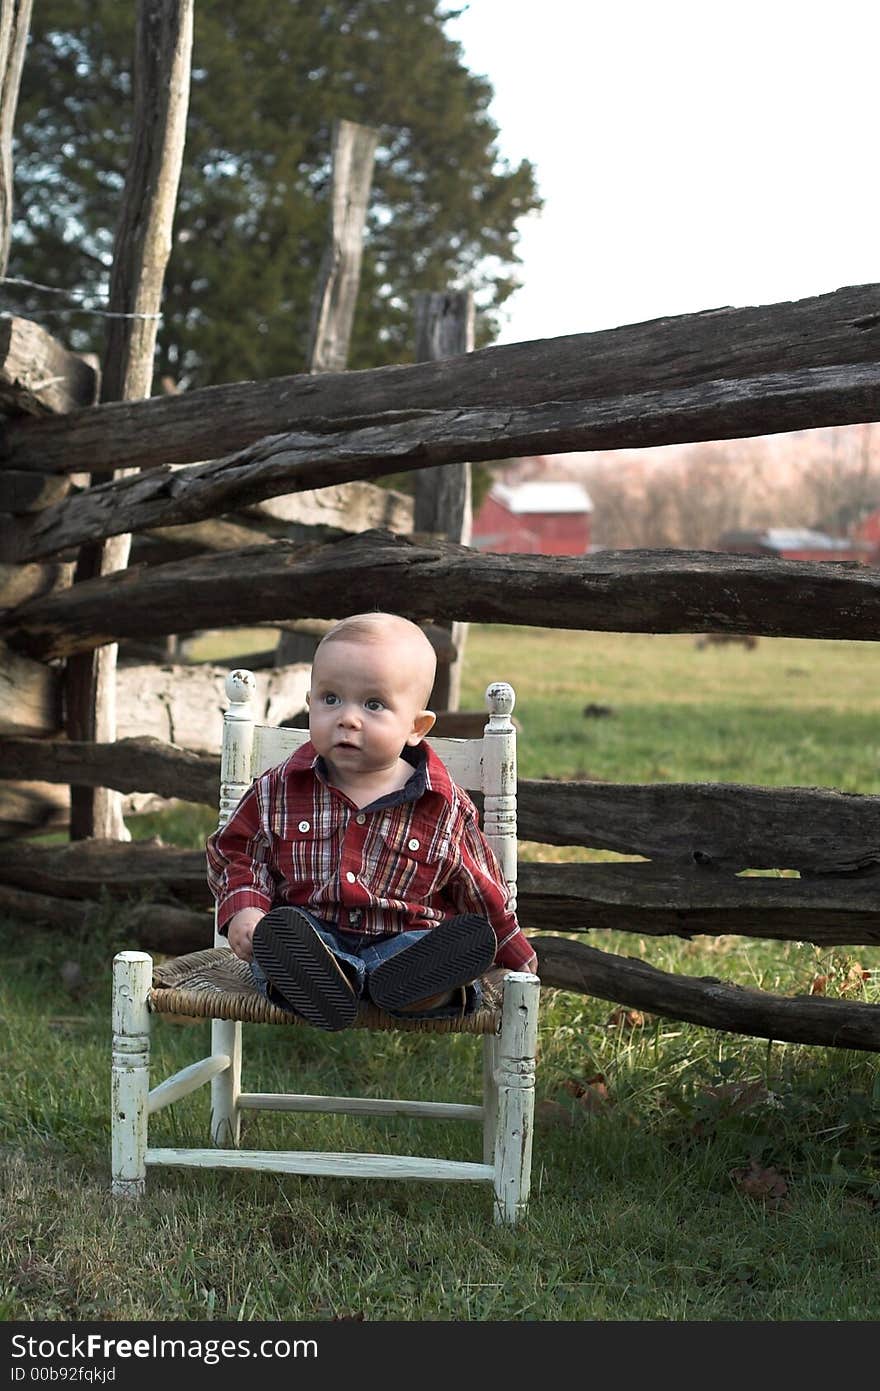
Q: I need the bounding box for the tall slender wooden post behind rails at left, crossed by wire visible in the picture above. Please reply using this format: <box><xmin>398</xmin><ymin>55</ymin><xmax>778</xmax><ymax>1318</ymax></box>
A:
<box><xmin>67</xmin><ymin>0</ymin><xmax>193</xmax><ymax>840</ymax></box>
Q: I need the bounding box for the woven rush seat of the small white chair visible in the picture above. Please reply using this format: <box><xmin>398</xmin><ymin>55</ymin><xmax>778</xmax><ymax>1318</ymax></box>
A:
<box><xmin>147</xmin><ymin>947</ymin><xmax>500</xmax><ymax>1034</ymax></box>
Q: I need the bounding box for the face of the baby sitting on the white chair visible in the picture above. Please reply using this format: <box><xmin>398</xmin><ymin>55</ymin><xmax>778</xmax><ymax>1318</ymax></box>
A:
<box><xmin>309</xmin><ymin>641</ymin><xmax>431</xmax><ymax>780</ymax></box>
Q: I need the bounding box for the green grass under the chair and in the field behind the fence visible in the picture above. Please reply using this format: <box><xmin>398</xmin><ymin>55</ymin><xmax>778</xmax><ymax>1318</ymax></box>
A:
<box><xmin>0</xmin><ymin>627</ymin><xmax>880</xmax><ymax>1321</ymax></box>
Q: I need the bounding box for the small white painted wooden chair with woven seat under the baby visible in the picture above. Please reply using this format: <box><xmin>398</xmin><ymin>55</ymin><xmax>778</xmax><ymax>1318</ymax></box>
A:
<box><xmin>111</xmin><ymin>670</ymin><xmax>539</xmax><ymax>1223</ymax></box>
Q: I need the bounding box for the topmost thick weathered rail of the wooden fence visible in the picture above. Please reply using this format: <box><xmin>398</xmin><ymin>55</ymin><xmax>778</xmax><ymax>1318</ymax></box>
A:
<box><xmin>0</xmin><ymin>285</ymin><xmax>880</xmax><ymax>481</ymax></box>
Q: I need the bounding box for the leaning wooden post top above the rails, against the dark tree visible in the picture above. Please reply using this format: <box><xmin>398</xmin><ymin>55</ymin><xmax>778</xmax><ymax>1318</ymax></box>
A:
<box><xmin>307</xmin><ymin>121</ymin><xmax>380</xmax><ymax>371</ymax></box>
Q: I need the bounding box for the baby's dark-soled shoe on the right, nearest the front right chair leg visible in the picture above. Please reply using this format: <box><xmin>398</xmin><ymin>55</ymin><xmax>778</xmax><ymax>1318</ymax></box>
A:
<box><xmin>368</xmin><ymin>914</ymin><xmax>498</xmax><ymax>1010</ymax></box>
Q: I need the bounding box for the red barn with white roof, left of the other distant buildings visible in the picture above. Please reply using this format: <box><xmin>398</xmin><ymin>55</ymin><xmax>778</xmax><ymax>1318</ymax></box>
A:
<box><xmin>471</xmin><ymin>480</ymin><xmax>592</xmax><ymax>555</ymax></box>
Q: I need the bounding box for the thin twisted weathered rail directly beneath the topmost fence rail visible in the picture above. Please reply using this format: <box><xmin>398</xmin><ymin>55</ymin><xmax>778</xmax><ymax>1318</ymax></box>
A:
<box><xmin>6</xmin><ymin>364</ymin><xmax>880</xmax><ymax>561</ymax></box>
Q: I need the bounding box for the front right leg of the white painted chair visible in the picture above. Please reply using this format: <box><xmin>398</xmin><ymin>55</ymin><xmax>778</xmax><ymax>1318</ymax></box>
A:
<box><xmin>495</xmin><ymin>971</ymin><xmax>541</xmax><ymax>1224</ymax></box>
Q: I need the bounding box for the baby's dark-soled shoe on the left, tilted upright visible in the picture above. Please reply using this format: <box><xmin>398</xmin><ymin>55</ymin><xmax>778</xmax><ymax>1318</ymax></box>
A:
<box><xmin>253</xmin><ymin>908</ymin><xmax>357</xmax><ymax>1029</ymax></box>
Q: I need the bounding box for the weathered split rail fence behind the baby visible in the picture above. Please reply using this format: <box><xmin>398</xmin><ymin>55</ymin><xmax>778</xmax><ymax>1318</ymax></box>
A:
<box><xmin>0</xmin><ymin>285</ymin><xmax>880</xmax><ymax>1050</ymax></box>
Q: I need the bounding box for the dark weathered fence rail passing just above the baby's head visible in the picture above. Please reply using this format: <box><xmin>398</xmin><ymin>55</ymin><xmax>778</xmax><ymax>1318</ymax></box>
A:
<box><xmin>0</xmin><ymin>531</ymin><xmax>880</xmax><ymax>659</ymax></box>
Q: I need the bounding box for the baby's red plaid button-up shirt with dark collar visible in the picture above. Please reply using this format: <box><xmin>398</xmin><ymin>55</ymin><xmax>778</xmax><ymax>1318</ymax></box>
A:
<box><xmin>207</xmin><ymin>743</ymin><xmax>532</xmax><ymax>970</ymax></box>
